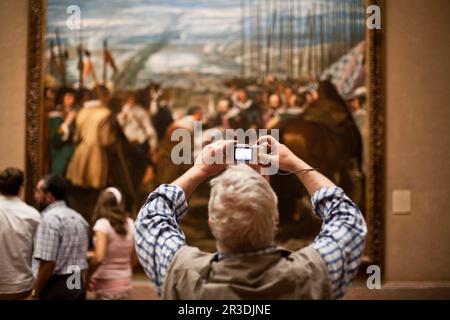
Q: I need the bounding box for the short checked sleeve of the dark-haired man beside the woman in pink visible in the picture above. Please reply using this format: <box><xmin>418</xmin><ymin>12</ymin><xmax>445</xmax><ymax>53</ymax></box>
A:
<box><xmin>33</xmin><ymin>215</ymin><xmax>60</xmax><ymax>261</ymax></box>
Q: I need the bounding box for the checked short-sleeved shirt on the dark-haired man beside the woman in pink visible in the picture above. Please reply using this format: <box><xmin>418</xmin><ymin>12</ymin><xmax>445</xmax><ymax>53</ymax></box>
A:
<box><xmin>32</xmin><ymin>201</ymin><xmax>89</xmax><ymax>277</ymax></box>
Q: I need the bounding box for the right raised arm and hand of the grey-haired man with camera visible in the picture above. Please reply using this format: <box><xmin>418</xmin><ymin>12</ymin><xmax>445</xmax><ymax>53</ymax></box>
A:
<box><xmin>258</xmin><ymin>136</ymin><xmax>367</xmax><ymax>298</ymax></box>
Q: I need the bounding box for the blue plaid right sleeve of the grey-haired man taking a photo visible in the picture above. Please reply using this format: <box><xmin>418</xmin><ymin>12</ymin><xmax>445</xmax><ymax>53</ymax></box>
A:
<box><xmin>312</xmin><ymin>187</ymin><xmax>367</xmax><ymax>299</ymax></box>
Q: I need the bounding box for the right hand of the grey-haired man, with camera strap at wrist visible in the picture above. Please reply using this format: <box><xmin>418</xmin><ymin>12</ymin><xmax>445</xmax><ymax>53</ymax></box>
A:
<box><xmin>256</xmin><ymin>136</ymin><xmax>307</xmax><ymax>172</ymax></box>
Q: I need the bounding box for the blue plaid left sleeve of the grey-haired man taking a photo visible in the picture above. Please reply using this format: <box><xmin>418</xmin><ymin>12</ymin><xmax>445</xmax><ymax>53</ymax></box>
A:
<box><xmin>134</xmin><ymin>184</ymin><xmax>188</xmax><ymax>295</ymax></box>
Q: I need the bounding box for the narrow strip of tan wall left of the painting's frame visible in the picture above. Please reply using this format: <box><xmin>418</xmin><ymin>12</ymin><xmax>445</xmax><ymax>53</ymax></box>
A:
<box><xmin>0</xmin><ymin>0</ymin><xmax>28</xmax><ymax>172</ymax></box>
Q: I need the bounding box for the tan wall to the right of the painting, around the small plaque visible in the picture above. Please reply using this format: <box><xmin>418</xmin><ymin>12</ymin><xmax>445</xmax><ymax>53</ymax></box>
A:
<box><xmin>384</xmin><ymin>0</ymin><xmax>450</xmax><ymax>282</ymax></box>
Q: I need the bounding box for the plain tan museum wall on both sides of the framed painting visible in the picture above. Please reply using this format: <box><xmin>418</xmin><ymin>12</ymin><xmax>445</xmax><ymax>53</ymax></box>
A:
<box><xmin>0</xmin><ymin>0</ymin><xmax>450</xmax><ymax>282</ymax></box>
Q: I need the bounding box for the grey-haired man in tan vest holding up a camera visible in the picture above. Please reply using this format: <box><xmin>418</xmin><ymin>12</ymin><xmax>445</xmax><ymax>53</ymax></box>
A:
<box><xmin>135</xmin><ymin>136</ymin><xmax>367</xmax><ymax>299</ymax></box>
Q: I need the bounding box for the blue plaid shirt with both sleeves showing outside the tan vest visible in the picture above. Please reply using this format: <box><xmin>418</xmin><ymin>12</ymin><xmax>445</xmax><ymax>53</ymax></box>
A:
<box><xmin>135</xmin><ymin>185</ymin><xmax>367</xmax><ymax>298</ymax></box>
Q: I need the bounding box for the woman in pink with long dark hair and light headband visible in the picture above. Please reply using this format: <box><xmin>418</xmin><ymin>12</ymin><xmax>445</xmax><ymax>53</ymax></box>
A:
<box><xmin>89</xmin><ymin>188</ymin><xmax>138</xmax><ymax>300</ymax></box>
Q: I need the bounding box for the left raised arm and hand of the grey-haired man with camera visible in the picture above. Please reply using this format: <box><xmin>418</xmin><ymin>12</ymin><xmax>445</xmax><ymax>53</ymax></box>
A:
<box><xmin>135</xmin><ymin>141</ymin><xmax>234</xmax><ymax>295</ymax></box>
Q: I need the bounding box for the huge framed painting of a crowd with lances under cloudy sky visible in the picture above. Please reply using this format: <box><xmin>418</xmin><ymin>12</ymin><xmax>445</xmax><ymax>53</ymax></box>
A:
<box><xmin>28</xmin><ymin>0</ymin><xmax>382</xmax><ymax>260</ymax></box>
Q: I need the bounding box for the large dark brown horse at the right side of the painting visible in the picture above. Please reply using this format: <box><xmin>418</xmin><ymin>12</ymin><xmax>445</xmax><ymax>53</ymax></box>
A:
<box><xmin>271</xmin><ymin>81</ymin><xmax>363</xmax><ymax>222</ymax></box>
